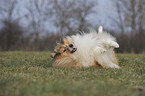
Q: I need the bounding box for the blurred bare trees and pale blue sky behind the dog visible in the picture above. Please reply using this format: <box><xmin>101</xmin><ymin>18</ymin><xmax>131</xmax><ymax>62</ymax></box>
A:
<box><xmin>0</xmin><ymin>0</ymin><xmax>145</xmax><ymax>53</ymax></box>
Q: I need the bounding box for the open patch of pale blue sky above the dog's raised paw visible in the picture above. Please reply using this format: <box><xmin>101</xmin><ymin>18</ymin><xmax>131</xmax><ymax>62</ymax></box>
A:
<box><xmin>90</xmin><ymin>0</ymin><xmax>116</xmax><ymax>29</ymax></box>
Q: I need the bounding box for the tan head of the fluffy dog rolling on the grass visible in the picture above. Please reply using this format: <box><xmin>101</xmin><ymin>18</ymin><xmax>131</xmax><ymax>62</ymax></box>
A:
<box><xmin>51</xmin><ymin>43</ymin><xmax>77</xmax><ymax>58</ymax></box>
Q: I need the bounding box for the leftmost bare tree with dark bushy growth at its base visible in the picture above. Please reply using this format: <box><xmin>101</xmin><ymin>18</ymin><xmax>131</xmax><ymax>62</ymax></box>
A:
<box><xmin>0</xmin><ymin>0</ymin><xmax>23</xmax><ymax>50</ymax></box>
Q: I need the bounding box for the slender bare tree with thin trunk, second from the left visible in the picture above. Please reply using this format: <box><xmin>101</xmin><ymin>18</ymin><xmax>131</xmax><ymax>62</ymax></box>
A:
<box><xmin>25</xmin><ymin>0</ymin><xmax>49</xmax><ymax>50</ymax></box>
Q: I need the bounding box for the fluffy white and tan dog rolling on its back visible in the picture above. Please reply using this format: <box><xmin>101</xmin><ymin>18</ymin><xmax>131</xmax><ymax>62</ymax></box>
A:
<box><xmin>51</xmin><ymin>26</ymin><xmax>120</xmax><ymax>68</ymax></box>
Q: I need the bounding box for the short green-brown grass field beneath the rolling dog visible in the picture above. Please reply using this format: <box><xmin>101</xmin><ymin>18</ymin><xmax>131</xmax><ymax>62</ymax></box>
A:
<box><xmin>0</xmin><ymin>52</ymin><xmax>145</xmax><ymax>96</ymax></box>
